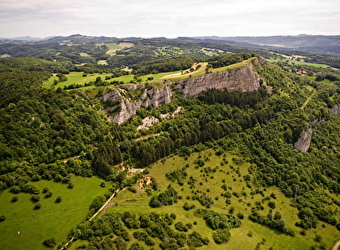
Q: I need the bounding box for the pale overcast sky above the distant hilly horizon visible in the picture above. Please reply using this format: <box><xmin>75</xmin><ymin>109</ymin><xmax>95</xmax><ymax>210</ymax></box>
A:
<box><xmin>0</xmin><ymin>0</ymin><xmax>340</xmax><ymax>38</ymax></box>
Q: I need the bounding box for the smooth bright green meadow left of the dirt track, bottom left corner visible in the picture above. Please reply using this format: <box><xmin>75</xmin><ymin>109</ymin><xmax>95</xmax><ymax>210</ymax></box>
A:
<box><xmin>0</xmin><ymin>176</ymin><xmax>107</xmax><ymax>250</ymax></box>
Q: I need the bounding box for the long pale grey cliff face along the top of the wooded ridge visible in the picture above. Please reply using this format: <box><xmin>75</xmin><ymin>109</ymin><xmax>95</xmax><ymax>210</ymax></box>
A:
<box><xmin>100</xmin><ymin>57</ymin><xmax>266</xmax><ymax>124</ymax></box>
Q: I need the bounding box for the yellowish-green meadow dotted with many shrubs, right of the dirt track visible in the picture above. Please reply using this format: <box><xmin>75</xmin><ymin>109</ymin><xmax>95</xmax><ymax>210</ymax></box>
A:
<box><xmin>88</xmin><ymin>150</ymin><xmax>339</xmax><ymax>249</ymax></box>
